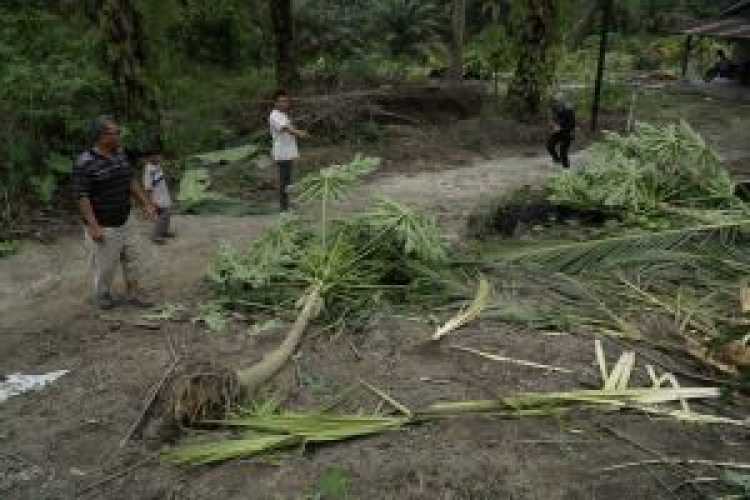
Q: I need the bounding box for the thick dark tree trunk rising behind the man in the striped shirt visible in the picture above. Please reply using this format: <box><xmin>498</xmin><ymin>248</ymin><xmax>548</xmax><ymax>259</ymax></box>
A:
<box><xmin>99</xmin><ymin>0</ymin><xmax>159</xmax><ymax>127</ymax></box>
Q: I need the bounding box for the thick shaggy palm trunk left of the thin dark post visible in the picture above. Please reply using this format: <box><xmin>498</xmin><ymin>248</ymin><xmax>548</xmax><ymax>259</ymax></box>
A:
<box><xmin>507</xmin><ymin>0</ymin><xmax>558</xmax><ymax>120</ymax></box>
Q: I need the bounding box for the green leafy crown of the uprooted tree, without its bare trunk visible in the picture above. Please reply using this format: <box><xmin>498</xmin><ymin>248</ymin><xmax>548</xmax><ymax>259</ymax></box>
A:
<box><xmin>210</xmin><ymin>156</ymin><xmax>462</xmax><ymax>319</ymax></box>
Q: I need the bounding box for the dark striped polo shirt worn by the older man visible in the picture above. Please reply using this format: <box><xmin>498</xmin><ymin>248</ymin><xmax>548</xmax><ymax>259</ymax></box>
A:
<box><xmin>73</xmin><ymin>149</ymin><xmax>134</xmax><ymax>227</ymax></box>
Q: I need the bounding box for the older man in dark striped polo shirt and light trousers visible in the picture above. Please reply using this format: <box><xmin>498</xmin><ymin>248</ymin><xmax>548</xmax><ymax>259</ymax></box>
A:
<box><xmin>73</xmin><ymin>117</ymin><xmax>156</xmax><ymax>309</ymax></box>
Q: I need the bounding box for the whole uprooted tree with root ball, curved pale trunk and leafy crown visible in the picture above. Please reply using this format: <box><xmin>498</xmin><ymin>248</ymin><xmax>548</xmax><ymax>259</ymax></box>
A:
<box><xmin>161</xmin><ymin>157</ymin><xmax>456</xmax><ymax>430</ymax></box>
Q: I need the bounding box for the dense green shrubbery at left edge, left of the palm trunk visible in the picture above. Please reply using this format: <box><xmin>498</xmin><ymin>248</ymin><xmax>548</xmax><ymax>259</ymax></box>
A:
<box><xmin>0</xmin><ymin>5</ymin><xmax>109</xmax><ymax>217</ymax></box>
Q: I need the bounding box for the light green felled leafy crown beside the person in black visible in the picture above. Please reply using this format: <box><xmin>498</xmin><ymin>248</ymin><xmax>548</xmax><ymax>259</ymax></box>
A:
<box><xmin>547</xmin><ymin>122</ymin><xmax>742</xmax><ymax>221</ymax></box>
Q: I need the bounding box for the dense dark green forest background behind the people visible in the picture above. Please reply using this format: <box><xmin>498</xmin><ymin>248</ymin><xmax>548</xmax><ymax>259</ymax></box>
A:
<box><xmin>0</xmin><ymin>0</ymin><xmax>733</xmax><ymax>227</ymax></box>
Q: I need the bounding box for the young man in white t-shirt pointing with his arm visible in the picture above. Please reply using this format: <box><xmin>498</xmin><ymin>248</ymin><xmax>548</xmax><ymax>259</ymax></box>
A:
<box><xmin>268</xmin><ymin>90</ymin><xmax>308</xmax><ymax>211</ymax></box>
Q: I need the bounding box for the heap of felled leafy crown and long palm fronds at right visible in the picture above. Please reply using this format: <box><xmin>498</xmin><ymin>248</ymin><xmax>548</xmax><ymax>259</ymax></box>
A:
<box><xmin>482</xmin><ymin>123</ymin><xmax>750</xmax><ymax>373</ymax></box>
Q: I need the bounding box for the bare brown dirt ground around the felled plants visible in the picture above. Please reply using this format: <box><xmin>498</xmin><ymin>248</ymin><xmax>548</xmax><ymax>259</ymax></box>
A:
<box><xmin>0</xmin><ymin>87</ymin><xmax>750</xmax><ymax>500</ymax></box>
